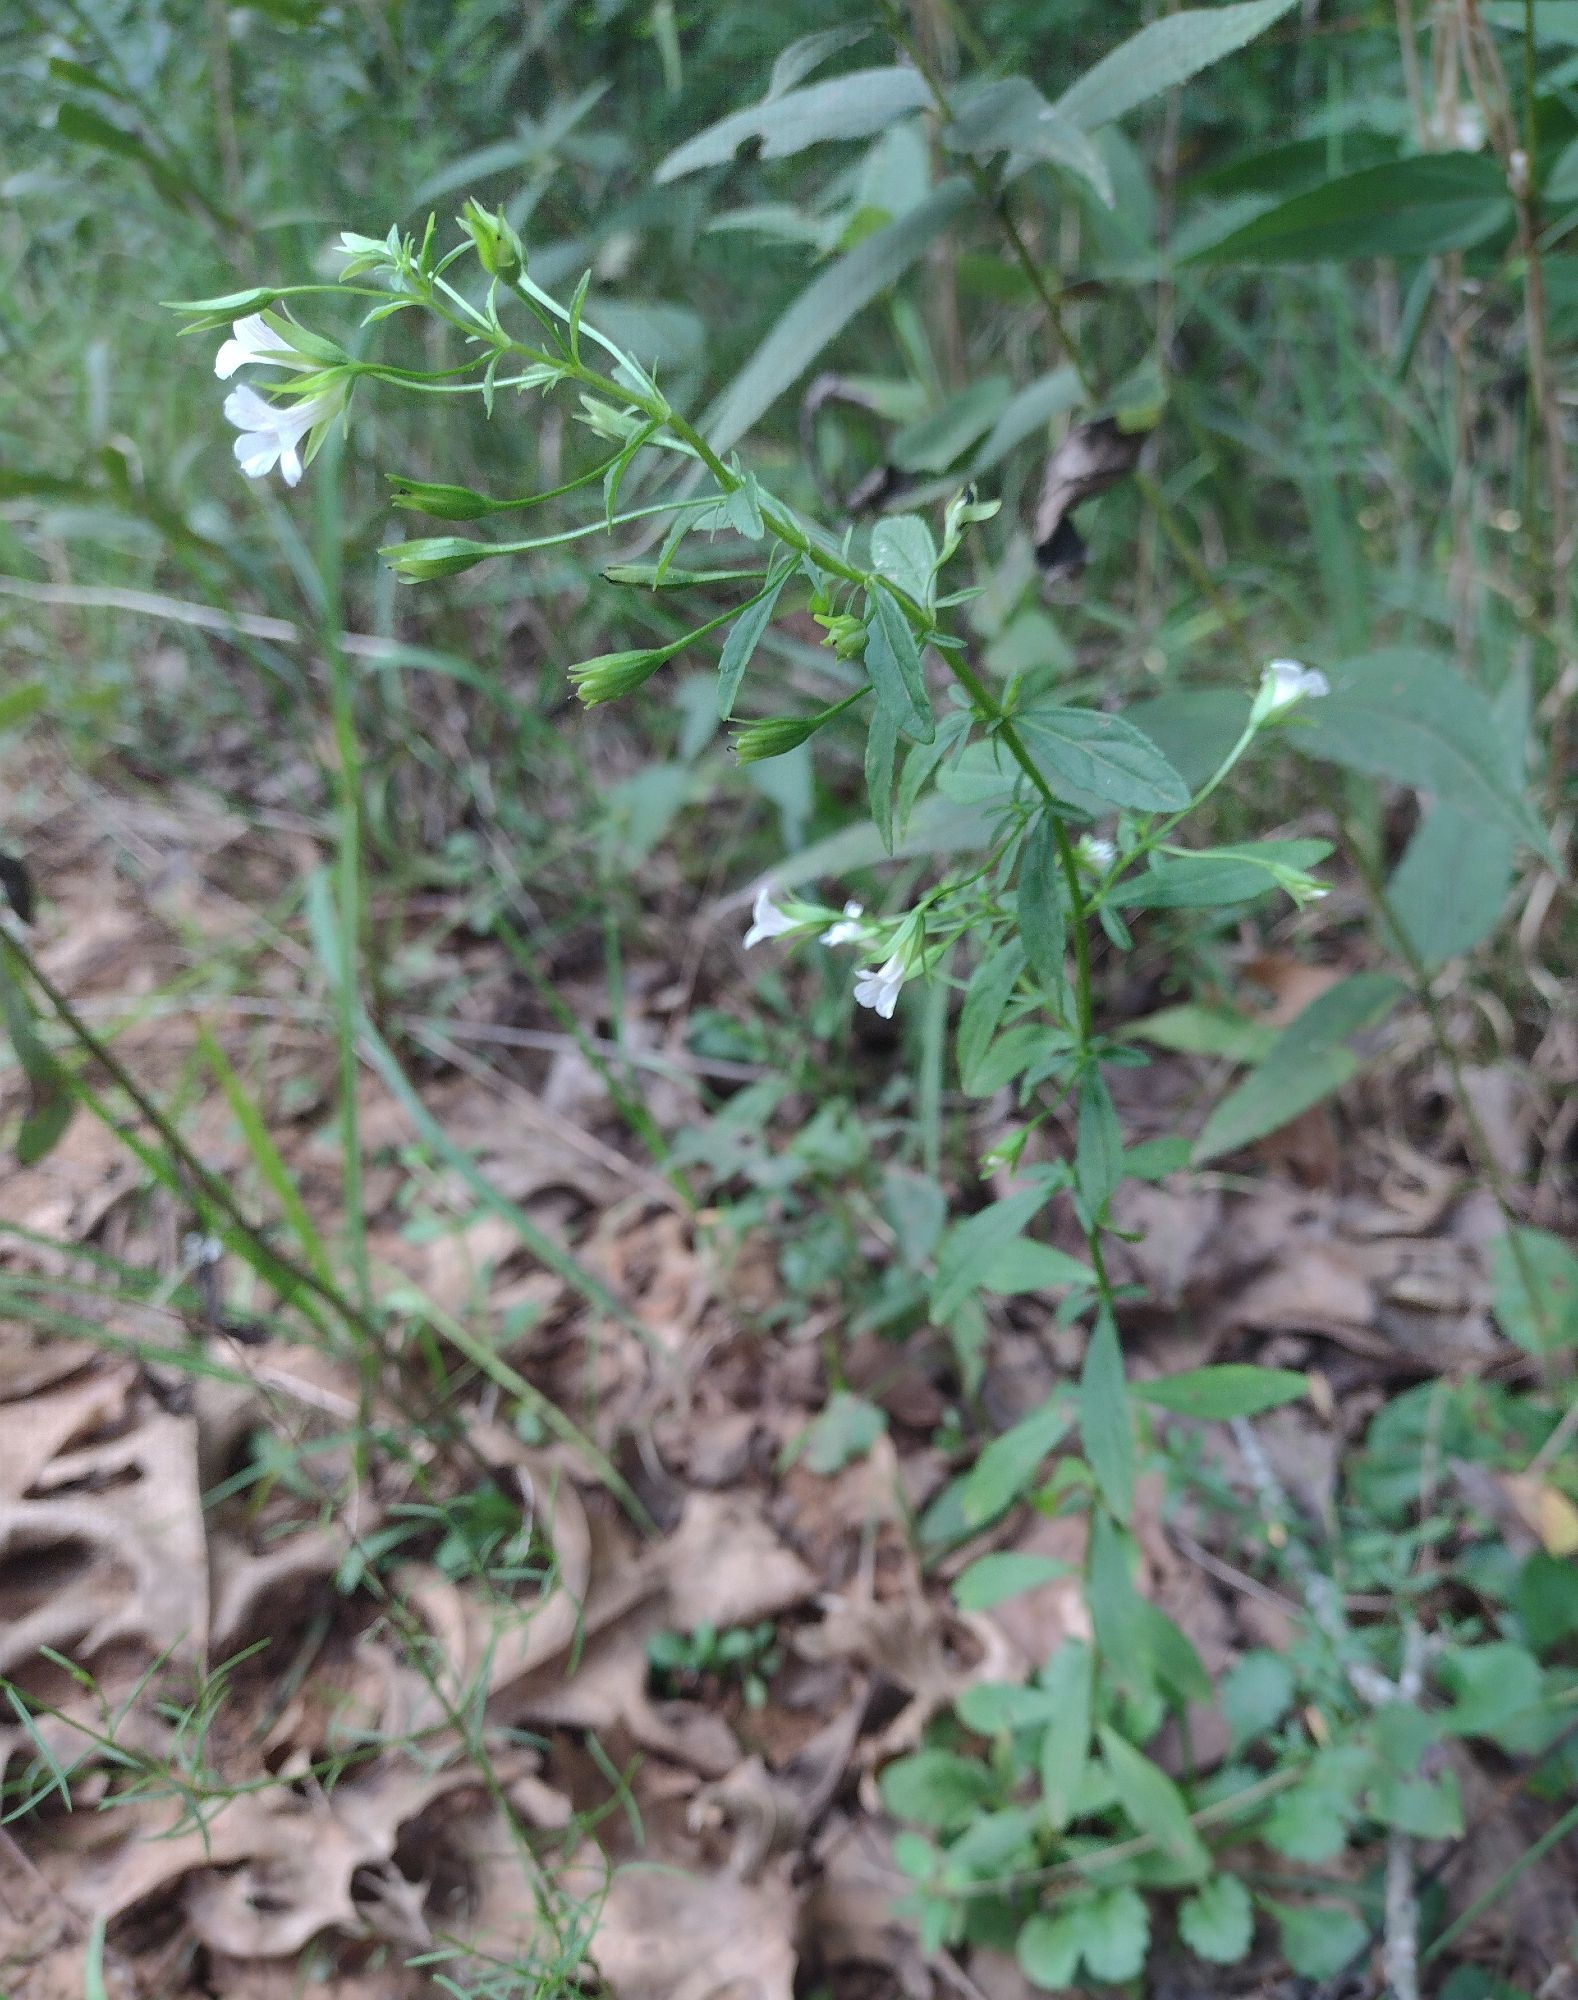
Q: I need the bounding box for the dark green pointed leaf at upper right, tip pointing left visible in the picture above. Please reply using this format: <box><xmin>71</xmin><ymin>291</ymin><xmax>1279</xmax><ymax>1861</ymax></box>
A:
<box><xmin>1190</xmin><ymin>152</ymin><xmax>1512</xmax><ymax>264</ymax></box>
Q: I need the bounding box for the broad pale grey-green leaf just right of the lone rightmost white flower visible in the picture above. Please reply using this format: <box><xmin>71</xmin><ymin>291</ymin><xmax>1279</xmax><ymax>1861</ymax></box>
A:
<box><xmin>1288</xmin><ymin>646</ymin><xmax>1550</xmax><ymax>854</ymax></box>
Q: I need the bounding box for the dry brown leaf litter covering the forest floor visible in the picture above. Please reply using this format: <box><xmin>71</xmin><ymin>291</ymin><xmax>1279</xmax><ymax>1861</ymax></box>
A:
<box><xmin>0</xmin><ymin>768</ymin><xmax>1570</xmax><ymax>2000</ymax></box>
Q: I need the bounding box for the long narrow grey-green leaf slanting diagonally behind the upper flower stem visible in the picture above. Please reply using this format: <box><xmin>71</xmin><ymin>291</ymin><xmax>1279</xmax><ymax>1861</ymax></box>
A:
<box><xmin>702</xmin><ymin>176</ymin><xmax>970</xmax><ymax>452</ymax></box>
